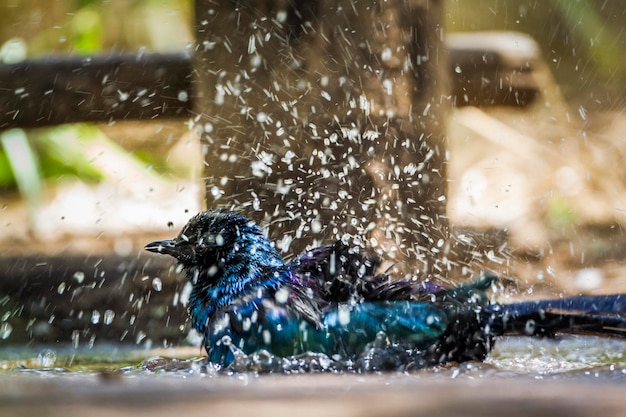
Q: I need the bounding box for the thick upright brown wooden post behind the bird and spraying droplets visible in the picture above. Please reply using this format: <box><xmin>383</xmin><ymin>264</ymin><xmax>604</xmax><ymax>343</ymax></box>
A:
<box><xmin>194</xmin><ymin>0</ymin><xmax>448</xmax><ymax>275</ymax></box>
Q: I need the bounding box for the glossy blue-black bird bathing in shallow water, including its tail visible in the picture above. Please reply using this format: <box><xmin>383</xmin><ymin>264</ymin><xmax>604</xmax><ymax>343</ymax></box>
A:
<box><xmin>145</xmin><ymin>209</ymin><xmax>626</xmax><ymax>371</ymax></box>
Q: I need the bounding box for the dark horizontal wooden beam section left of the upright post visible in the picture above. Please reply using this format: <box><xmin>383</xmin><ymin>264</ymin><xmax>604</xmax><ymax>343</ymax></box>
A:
<box><xmin>0</xmin><ymin>53</ymin><xmax>191</xmax><ymax>129</ymax></box>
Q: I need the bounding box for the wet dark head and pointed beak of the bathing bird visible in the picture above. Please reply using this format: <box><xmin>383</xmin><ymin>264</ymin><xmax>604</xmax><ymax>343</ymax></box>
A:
<box><xmin>145</xmin><ymin>210</ymin><xmax>267</xmax><ymax>270</ymax></box>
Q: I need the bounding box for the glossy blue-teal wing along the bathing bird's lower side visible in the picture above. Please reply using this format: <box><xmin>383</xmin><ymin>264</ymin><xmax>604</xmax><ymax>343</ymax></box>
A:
<box><xmin>207</xmin><ymin>298</ymin><xmax>449</xmax><ymax>365</ymax></box>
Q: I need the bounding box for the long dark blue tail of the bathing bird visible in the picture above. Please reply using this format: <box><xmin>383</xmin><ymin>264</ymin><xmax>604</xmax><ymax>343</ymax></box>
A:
<box><xmin>483</xmin><ymin>294</ymin><xmax>626</xmax><ymax>337</ymax></box>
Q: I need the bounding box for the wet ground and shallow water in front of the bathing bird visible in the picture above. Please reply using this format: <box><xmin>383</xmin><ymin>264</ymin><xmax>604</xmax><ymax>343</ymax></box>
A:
<box><xmin>0</xmin><ymin>336</ymin><xmax>626</xmax><ymax>417</ymax></box>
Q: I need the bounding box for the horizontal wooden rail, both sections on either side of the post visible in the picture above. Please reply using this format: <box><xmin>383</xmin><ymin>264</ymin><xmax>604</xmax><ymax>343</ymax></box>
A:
<box><xmin>0</xmin><ymin>32</ymin><xmax>540</xmax><ymax>129</ymax></box>
